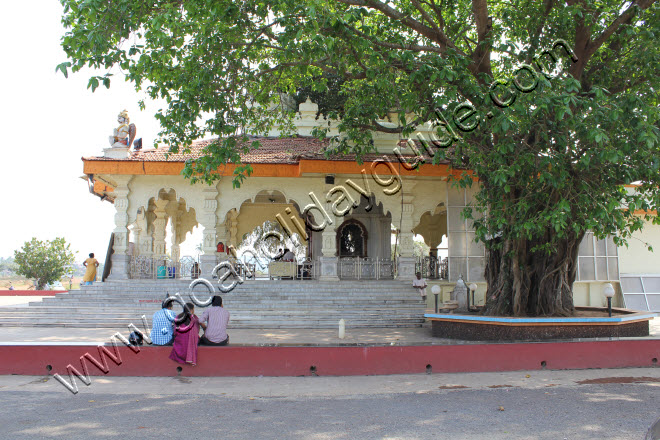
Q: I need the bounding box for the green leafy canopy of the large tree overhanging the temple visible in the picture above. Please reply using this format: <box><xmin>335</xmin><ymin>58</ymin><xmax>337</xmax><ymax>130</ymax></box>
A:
<box><xmin>58</xmin><ymin>0</ymin><xmax>660</xmax><ymax>312</ymax></box>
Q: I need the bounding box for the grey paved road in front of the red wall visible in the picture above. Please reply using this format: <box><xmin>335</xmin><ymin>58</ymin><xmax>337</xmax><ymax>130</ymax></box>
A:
<box><xmin>0</xmin><ymin>368</ymin><xmax>660</xmax><ymax>440</ymax></box>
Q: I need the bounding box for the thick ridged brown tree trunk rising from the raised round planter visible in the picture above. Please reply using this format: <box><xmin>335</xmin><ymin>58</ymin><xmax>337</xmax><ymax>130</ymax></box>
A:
<box><xmin>484</xmin><ymin>232</ymin><xmax>583</xmax><ymax>316</ymax></box>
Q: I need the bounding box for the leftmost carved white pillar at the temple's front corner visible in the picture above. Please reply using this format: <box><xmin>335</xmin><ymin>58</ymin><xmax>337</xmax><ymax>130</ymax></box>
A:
<box><xmin>108</xmin><ymin>176</ymin><xmax>132</xmax><ymax>280</ymax></box>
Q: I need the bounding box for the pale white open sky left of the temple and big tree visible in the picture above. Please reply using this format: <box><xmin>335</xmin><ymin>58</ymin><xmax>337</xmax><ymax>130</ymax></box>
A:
<box><xmin>0</xmin><ymin>0</ymin><xmax>165</xmax><ymax>262</ymax></box>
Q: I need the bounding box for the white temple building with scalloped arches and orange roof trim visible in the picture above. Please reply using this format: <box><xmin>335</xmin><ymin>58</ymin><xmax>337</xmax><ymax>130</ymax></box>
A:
<box><xmin>83</xmin><ymin>101</ymin><xmax>660</xmax><ymax>310</ymax></box>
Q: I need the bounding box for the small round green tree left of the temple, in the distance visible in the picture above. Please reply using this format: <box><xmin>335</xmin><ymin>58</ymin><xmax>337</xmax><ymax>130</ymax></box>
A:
<box><xmin>14</xmin><ymin>238</ymin><xmax>74</xmax><ymax>290</ymax></box>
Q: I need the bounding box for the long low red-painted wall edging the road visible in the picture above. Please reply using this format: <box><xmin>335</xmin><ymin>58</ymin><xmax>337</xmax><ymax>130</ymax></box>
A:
<box><xmin>0</xmin><ymin>339</ymin><xmax>660</xmax><ymax>377</ymax></box>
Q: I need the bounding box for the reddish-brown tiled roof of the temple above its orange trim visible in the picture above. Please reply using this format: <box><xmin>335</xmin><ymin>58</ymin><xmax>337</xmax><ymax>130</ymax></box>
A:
<box><xmin>83</xmin><ymin>136</ymin><xmax>448</xmax><ymax>164</ymax></box>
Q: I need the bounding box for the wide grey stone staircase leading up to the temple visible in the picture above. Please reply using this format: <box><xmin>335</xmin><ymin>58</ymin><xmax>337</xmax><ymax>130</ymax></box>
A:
<box><xmin>0</xmin><ymin>280</ymin><xmax>424</xmax><ymax>329</ymax></box>
